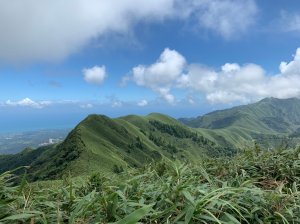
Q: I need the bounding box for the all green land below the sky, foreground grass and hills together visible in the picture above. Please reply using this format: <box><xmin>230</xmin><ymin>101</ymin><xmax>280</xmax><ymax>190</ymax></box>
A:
<box><xmin>0</xmin><ymin>98</ymin><xmax>300</xmax><ymax>224</ymax></box>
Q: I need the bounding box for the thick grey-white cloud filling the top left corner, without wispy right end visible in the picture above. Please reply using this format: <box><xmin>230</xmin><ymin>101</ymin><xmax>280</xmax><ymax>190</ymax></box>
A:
<box><xmin>0</xmin><ymin>0</ymin><xmax>174</xmax><ymax>62</ymax></box>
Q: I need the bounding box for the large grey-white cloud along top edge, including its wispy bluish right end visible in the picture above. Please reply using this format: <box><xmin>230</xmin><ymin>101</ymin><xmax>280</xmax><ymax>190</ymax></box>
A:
<box><xmin>0</xmin><ymin>0</ymin><xmax>257</xmax><ymax>63</ymax></box>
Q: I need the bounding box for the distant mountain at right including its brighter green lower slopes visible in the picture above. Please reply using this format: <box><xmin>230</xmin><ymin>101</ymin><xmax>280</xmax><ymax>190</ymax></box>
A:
<box><xmin>179</xmin><ymin>98</ymin><xmax>300</xmax><ymax>148</ymax></box>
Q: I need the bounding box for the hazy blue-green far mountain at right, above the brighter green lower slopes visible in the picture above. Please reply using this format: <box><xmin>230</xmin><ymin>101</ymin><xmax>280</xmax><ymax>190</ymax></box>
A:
<box><xmin>181</xmin><ymin>98</ymin><xmax>300</xmax><ymax>133</ymax></box>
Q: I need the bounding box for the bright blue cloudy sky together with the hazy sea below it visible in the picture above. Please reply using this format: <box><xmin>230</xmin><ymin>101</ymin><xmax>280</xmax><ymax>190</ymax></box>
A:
<box><xmin>0</xmin><ymin>0</ymin><xmax>300</xmax><ymax>132</ymax></box>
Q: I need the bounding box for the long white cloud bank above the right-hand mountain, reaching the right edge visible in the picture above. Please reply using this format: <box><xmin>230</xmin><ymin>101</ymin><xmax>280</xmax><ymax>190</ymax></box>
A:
<box><xmin>179</xmin><ymin>52</ymin><xmax>300</xmax><ymax>103</ymax></box>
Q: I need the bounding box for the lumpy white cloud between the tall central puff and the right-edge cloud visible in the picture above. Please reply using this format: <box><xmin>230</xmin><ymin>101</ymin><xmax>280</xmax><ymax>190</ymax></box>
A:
<box><xmin>178</xmin><ymin>63</ymin><xmax>266</xmax><ymax>103</ymax></box>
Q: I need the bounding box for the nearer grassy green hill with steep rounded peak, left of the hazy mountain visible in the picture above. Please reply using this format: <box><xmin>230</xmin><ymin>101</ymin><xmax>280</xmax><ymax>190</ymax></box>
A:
<box><xmin>0</xmin><ymin>114</ymin><xmax>235</xmax><ymax>180</ymax></box>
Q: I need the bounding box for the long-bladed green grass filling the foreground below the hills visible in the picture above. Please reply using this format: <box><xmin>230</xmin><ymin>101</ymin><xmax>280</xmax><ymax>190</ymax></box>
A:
<box><xmin>0</xmin><ymin>145</ymin><xmax>300</xmax><ymax>223</ymax></box>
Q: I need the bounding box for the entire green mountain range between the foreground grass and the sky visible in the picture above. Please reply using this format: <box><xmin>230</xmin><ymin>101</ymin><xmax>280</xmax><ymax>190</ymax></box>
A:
<box><xmin>0</xmin><ymin>98</ymin><xmax>300</xmax><ymax>180</ymax></box>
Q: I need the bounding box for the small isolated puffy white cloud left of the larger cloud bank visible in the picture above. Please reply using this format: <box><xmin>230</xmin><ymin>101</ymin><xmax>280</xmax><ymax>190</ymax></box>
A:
<box><xmin>82</xmin><ymin>66</ymin><xmax>107</xmax><ymax>85</ymax></box>
